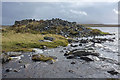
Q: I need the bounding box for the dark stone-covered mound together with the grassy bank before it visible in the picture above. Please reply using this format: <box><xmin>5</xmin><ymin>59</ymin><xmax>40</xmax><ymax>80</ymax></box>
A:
<box><xmin>2</xmin><ymin>18</ymin><xmax>112</xmax><ymax>52</ymax></box>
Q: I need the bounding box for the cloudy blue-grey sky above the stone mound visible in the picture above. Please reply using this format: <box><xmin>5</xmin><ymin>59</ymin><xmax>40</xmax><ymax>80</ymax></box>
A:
<box><xmin>2</xmin><ymin>1</ymin><xmax>119</xmax><ymax>25</ymax></box>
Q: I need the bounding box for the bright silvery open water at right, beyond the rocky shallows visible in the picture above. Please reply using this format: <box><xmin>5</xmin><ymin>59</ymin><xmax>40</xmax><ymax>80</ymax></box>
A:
<box><xmin>92</xmin><ymin>27</ymin><xmax>119</xmax><ymax>61</ymax></box>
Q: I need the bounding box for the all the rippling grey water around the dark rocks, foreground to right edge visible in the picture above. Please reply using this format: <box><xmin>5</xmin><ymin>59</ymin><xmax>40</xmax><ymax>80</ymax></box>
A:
<box><xmin>2</xmin><ymin>27</ymin><xmax>119</xmax><ymax>78</ymax></box>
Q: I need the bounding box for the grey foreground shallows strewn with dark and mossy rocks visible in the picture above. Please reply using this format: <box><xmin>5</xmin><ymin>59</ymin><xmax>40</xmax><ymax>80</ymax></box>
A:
<box><xmin>2</xmin><ymin>37</ymin><xmax>120</xmax><ymax>78</ymax></box>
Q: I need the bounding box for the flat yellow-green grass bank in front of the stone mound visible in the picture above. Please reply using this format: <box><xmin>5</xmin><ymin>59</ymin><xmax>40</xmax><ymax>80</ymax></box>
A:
<box><xmin>2</xmin><ymin>31</ymin><xmax>68</xmax><ymax>52</ymax></box>
